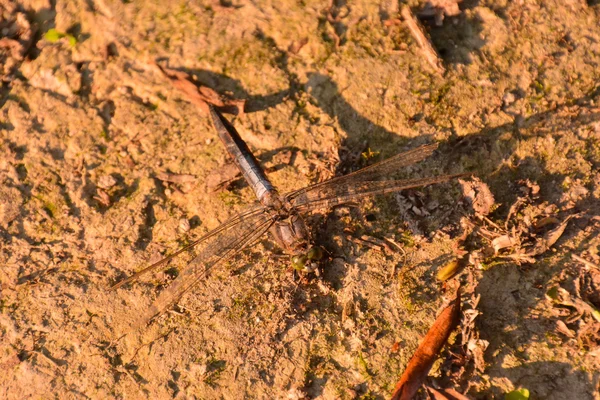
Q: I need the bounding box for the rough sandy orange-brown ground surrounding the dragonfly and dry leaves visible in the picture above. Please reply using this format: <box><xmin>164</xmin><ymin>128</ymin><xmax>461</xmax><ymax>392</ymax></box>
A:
<box><xmin>0</xmin><ymin>0</ymin><xmax>600</xmax><ymax>399</ymax></box>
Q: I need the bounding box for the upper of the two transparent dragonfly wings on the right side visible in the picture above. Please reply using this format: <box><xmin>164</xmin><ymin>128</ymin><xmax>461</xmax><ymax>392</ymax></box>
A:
<box><xmin>285</xmin><ymin>143</ymin><xmax>438</xmax><ymax>204</ymax></box>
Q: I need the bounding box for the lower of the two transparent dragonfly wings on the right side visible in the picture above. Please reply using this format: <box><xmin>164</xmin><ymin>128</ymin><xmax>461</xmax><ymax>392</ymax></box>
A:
<box><xmin>291</xmin><ymin>174</ymin><xmax>464</xmax><ymax>212</ymax></box>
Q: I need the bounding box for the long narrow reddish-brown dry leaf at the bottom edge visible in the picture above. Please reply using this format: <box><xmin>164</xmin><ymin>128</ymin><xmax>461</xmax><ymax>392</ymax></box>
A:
<box><xmin>392</xmin><ymin>292</ymin><xmax>460</xmax><ymax>400</ymax></box>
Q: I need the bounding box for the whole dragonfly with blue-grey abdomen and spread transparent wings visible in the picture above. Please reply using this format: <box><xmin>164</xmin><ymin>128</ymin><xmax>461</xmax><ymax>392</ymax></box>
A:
<box><xmin>113</xmin><ymin>106</ymin><xmax>464</xmax><ymax>326</ymax></box>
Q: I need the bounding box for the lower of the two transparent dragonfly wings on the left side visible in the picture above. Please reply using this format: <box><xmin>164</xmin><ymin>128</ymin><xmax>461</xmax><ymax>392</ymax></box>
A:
<box><xmin>135</xmin><ymin>209</ymin><xmax>274</xmax><ymax>327</ymax></box>
